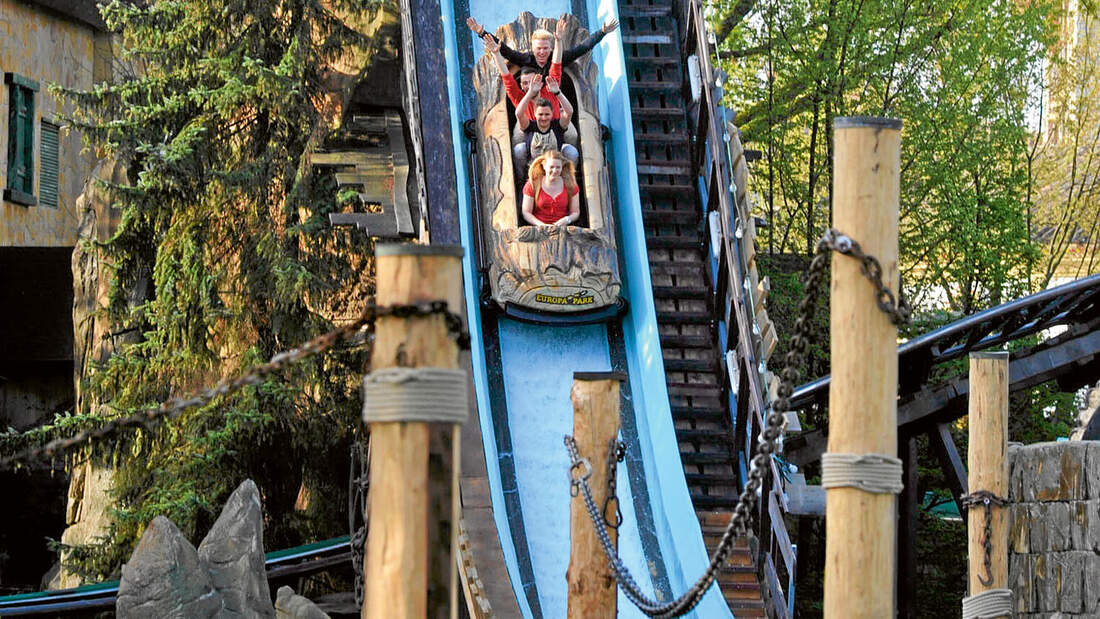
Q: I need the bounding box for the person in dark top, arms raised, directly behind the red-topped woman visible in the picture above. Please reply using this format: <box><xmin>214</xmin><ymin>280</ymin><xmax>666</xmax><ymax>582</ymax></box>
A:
<box><xmin>512</xmin><ymin>76</ymin><xmax>580</xmax><ymax>179</ymax></box>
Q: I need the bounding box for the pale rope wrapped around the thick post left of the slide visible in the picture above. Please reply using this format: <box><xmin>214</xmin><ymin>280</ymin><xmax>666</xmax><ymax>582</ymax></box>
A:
<box><xmin>363</xmin><ymin>367</ymin><xmax>470</xmax><ymax>423</ymax></box>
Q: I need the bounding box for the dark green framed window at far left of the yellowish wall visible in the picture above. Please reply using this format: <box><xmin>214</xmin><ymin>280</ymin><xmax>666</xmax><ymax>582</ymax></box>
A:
<box><xmin>3</xmin><ymin>73</ymin><xmax>39</xmax><ymax>207</ymax></box>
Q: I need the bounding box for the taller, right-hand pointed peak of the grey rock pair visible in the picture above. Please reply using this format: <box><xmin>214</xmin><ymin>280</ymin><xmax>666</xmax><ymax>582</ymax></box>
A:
<box><xmin>198</xmin><ymin>479</ymin><xmax>275</xmax><ymax>618</ymax></box>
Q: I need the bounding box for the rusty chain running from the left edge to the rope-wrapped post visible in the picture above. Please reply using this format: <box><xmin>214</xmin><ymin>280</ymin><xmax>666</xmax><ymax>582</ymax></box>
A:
<box><xmin>0</xmin><ymin>301</ymin><xmax>470</xmax><ymax>469</ymax></box>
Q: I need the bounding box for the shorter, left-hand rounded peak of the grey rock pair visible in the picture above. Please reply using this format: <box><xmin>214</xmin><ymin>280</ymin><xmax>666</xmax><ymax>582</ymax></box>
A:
<box><xmin>116</xmin><ymin>516</ymin><xmax>222</xmax><ymax>619</ymax></box>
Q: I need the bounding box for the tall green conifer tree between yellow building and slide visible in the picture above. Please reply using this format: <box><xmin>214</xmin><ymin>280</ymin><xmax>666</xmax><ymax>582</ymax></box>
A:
<box><xmin>34</xmin><ymin>0</ymin><xmax>377</xmax><ymax>576</ymax></box>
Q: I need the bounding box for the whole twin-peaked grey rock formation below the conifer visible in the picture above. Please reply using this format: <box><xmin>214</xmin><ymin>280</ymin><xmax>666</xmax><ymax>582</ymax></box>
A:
<box><xmin>116</xmin><ymin>479</ymin><xmax>275</xmax><ymax>619</ymax></box>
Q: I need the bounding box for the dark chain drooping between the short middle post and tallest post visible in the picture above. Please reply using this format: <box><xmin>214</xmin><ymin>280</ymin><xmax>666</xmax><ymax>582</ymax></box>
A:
<box><xmin>564</xmin><ymin>229</ymin><xmax>912</xmax><ymax>619</ymax></box>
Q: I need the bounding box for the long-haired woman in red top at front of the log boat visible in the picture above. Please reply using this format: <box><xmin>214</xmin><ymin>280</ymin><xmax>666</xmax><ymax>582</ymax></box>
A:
<box><xmin>523</xmin><ymin>151</ymin><xmax>581</xmax><ymax>225</ymax></box>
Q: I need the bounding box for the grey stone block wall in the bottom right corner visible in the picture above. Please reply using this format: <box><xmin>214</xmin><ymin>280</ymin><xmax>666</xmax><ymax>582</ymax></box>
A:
<box><xmin>1008</xmin><ymin>441</ymin><xmax>1100</xmax><ymax>618</ymax></box>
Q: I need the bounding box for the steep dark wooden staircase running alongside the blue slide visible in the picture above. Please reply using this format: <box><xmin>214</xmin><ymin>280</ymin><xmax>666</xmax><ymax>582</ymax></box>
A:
<box><xmin>619</xmin><ymin>0</ymin><xmax>766</xmax><ymax>617</ymax></box>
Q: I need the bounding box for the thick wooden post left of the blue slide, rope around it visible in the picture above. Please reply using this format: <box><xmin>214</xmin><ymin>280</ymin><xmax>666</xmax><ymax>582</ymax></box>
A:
<box><xmin>362</xmin><ymin>244</ymin><xmax>466</xmax><ymax>619</ymax></box>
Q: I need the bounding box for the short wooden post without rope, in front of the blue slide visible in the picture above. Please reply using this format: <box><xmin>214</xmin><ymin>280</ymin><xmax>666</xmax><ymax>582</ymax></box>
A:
<box><xmin>565</xmin><ymin>372</ymin><xmax>626</xmax><ymax>619</ymax></box>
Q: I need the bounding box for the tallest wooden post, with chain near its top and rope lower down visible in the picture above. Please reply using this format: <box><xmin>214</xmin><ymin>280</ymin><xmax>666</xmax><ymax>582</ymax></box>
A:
<box><xmin>825</xmin><ymin>118</ymin><xmax>901</xmax><ymax>619</ymax></box>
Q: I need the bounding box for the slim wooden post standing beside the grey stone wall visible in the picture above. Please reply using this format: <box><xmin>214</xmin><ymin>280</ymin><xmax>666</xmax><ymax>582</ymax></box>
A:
<box><xmin>967</xmin><ymin>352</ymin><xmax>1009</xmax><ymax>615</ymax></box>
